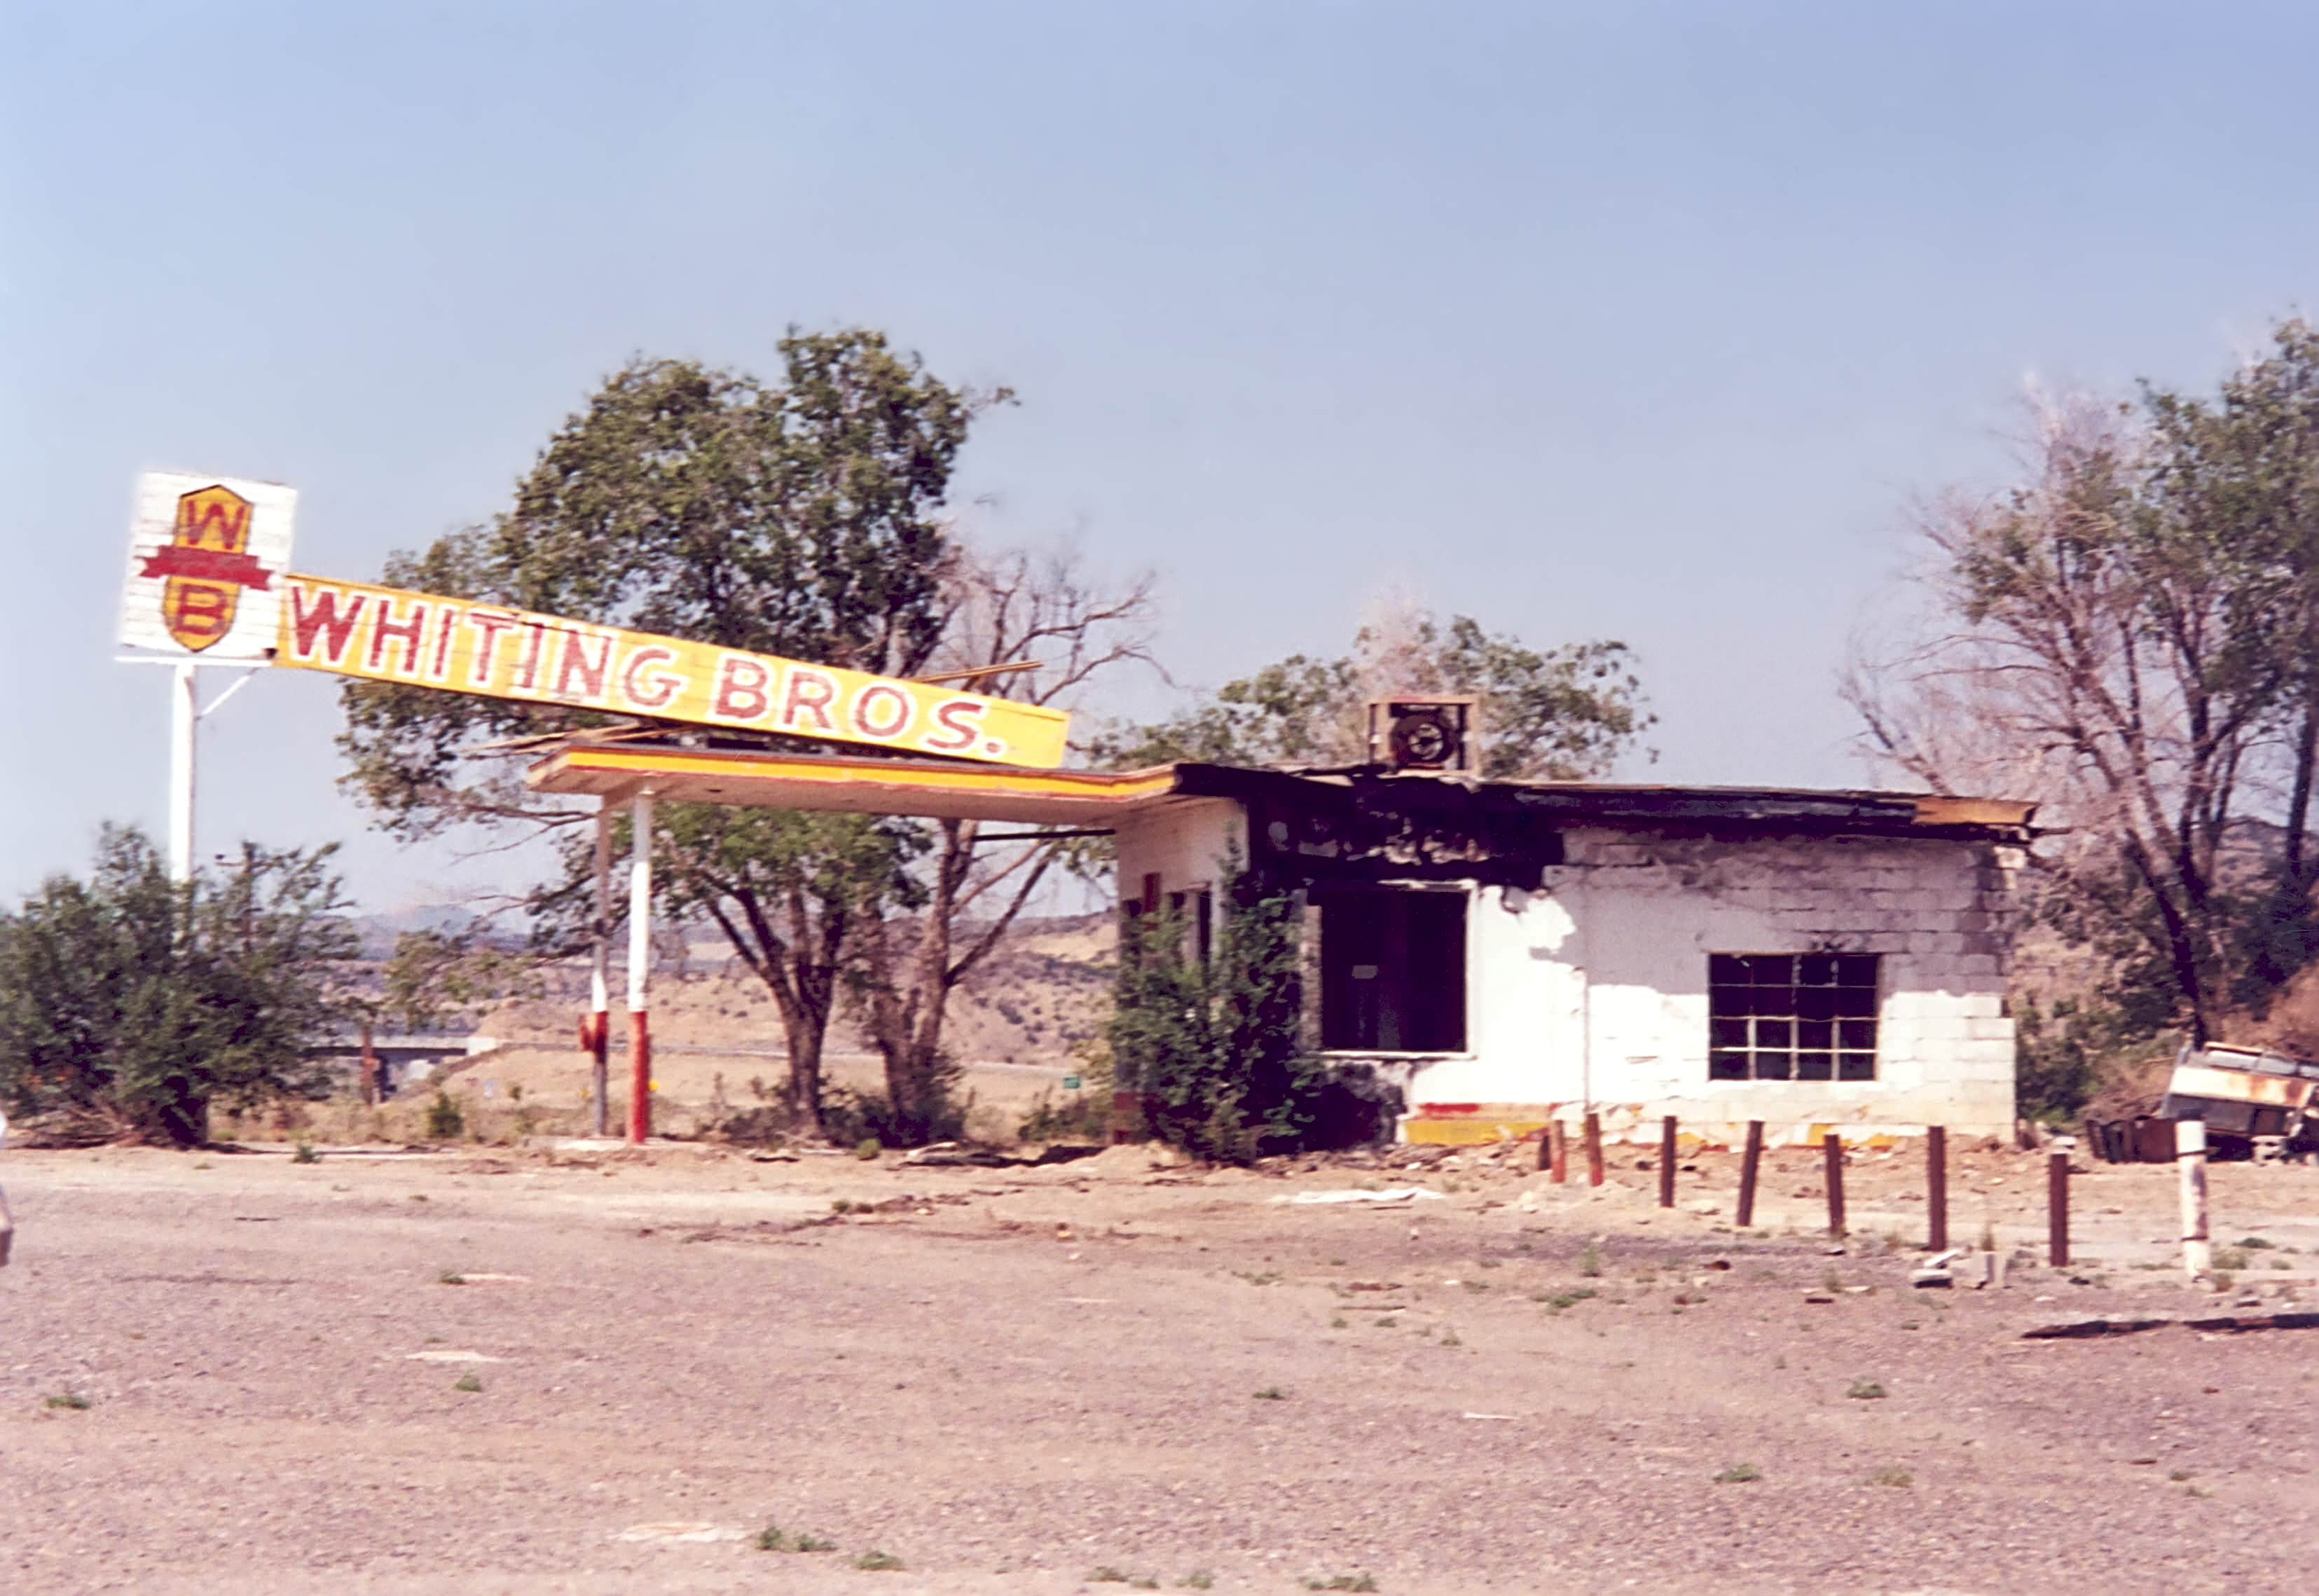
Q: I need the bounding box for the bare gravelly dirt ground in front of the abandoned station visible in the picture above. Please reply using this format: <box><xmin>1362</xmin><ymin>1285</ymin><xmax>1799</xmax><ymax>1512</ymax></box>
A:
<box><xmin>0</xmin><ymin>1146</ymin><xmax>2319</xmax><ymax>1596</ymax></box>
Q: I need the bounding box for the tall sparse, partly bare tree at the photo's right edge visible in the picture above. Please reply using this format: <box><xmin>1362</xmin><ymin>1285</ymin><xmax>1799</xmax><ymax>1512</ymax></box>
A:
<box><xmin>1846</xmin><ymin>322</ymin><xmax>2319</xmax><ymax>1071</ymax></box>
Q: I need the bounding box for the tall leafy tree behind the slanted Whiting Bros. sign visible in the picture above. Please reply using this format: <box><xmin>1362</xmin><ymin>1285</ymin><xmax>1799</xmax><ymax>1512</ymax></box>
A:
<box><xmin>341</xmin><ymin>329</ymin><xmax>1148</xmax><ymax>1139</ymax></box>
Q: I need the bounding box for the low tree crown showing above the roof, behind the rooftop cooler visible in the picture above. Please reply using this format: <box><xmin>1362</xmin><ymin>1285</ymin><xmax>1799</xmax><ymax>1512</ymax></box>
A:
<box><xmin>1094</xmin><ymin>605</ymin><xmax>1656</xmax><ymax>782</ymax></box>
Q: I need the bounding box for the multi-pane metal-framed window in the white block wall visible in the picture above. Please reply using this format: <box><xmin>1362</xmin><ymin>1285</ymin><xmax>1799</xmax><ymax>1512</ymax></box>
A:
<box><xmin>1707</xmin><ymin>954</ymin><xmax>1876</xmax><ymax>1081</ymax></box>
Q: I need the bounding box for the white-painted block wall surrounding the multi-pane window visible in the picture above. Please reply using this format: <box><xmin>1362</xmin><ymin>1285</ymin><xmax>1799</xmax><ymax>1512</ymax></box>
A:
<box><xmin>1405</xmin><ymin>833</ymin><xmax>2013</xmax><ymax>1134</ymax></box>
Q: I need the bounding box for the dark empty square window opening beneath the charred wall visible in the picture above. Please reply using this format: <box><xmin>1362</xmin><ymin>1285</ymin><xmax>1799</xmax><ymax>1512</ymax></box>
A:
<box><xmin>1312</xmin><ymin>888</ymin><xmax>1466</xmax><ymax>1053</ymax></box>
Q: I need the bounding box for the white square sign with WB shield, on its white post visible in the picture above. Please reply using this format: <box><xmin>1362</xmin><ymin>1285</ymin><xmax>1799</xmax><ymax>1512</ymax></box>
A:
<box><xmin>121</xmin><ymin>471</ymin><xmax>297</xmax><ymax>881</ymax></box>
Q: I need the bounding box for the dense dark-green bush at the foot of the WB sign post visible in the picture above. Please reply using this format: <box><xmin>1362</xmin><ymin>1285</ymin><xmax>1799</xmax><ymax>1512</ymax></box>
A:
<box><xmin>0</xmin><ymin>826</ymin><xmax>357</xmax><ymax>1146</ymax></box>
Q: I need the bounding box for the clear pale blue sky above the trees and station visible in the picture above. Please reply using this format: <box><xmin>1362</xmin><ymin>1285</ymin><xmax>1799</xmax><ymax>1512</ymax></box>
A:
<box><xmin>0</xmin><ymin>0</ymin><xmax>2319</xmax><ymax>907</ymax></box>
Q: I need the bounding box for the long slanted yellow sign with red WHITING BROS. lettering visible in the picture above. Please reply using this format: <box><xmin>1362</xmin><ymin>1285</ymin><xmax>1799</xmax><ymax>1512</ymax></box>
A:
<box><xmin>274</xmin><ymin>573</ymin><xmax>1071</xmax><ymax>768</ymax></box>
